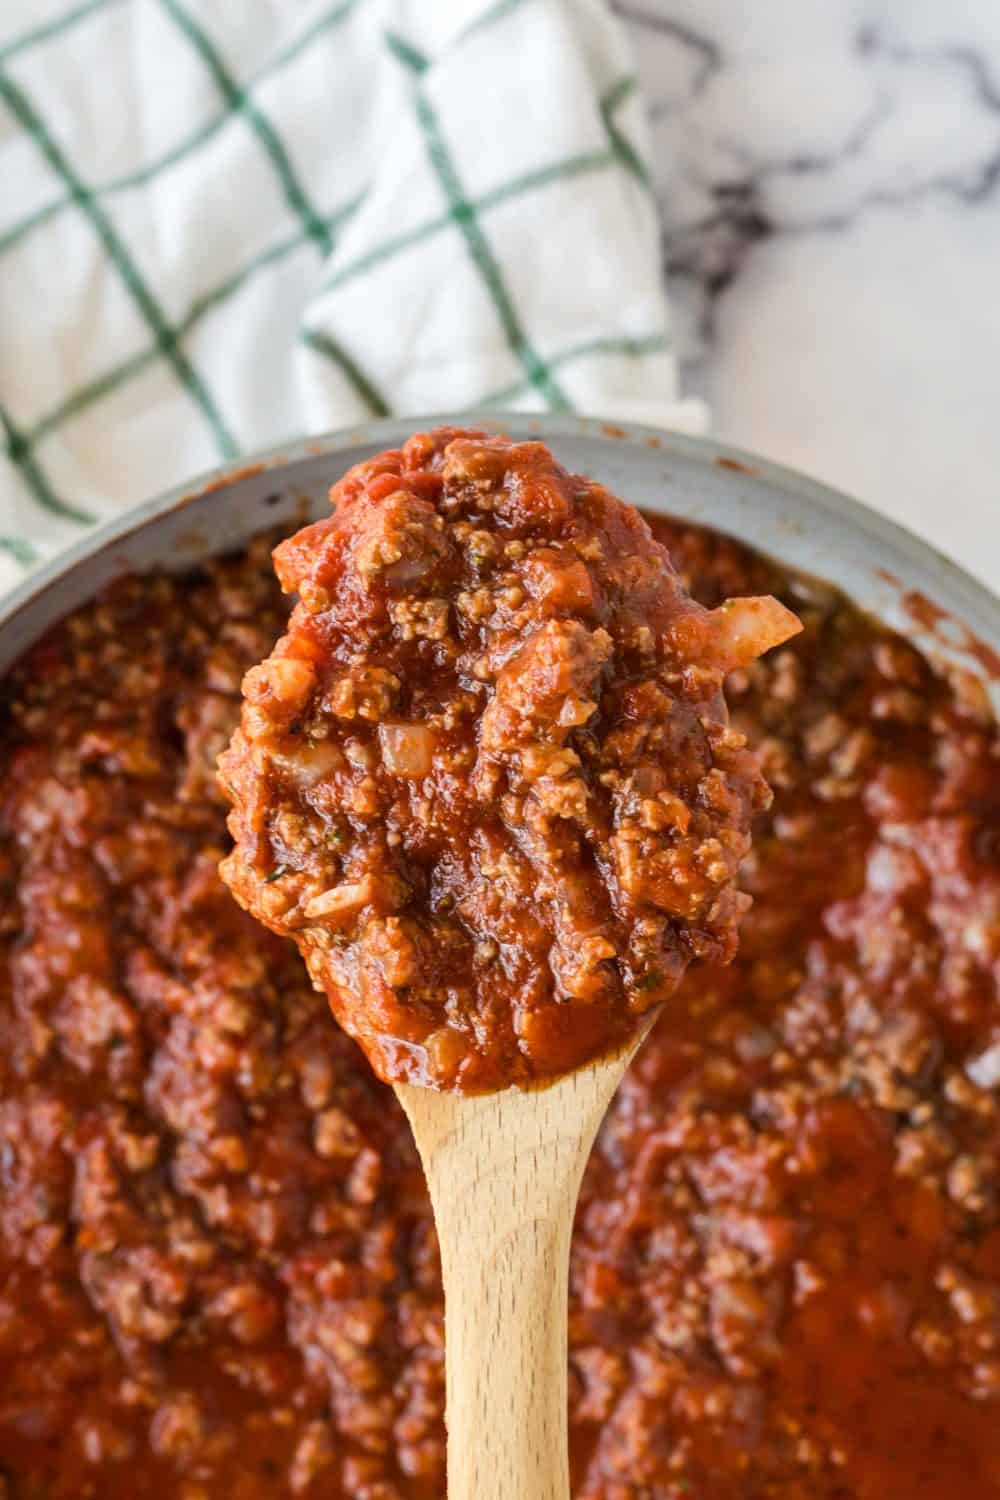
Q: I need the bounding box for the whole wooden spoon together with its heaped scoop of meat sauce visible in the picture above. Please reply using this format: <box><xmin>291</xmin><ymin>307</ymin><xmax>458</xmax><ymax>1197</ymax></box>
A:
<box><xmin>209</xmin><ymin>429</ymin><xmax>801</xmax><ymax>1500</ymax></box>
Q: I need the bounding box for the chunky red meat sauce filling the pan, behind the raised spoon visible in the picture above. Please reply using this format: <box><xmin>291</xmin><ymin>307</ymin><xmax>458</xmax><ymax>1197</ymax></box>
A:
<box><xmin>0</xmin><ymin>521</ymin><xmax>1000</xmax><ymax>1500</ymax></box>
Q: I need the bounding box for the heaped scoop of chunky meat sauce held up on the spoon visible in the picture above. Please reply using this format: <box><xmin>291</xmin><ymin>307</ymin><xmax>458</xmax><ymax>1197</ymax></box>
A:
<box><xmin>219</xmin><ymin>429</ymin><xmax>799</xmax><ymax>1092</ymax></box>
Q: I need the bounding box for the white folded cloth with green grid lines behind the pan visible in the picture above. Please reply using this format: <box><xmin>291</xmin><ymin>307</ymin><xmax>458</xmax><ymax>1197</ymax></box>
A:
<box><xmin>0</xmin><ymin>0</ymin><xmax>702</xmax><ymax>587</ymax></box>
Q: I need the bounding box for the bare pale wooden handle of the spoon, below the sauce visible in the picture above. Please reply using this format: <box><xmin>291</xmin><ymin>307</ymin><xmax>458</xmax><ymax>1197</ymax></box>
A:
<box><xmin>396</xmin><ymin>1017</ymin><xmax>652</xmax><ymax>1500</ymax></box>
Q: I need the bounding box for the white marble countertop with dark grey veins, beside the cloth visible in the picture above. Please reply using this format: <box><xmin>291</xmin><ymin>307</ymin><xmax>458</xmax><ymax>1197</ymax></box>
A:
<box><xmin>615</xmin><ymin>0</ymin><xmax>1000</xmax><ymax>588</ymax></box>
